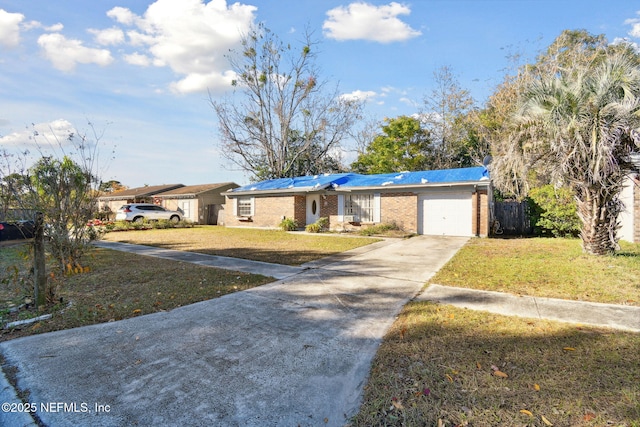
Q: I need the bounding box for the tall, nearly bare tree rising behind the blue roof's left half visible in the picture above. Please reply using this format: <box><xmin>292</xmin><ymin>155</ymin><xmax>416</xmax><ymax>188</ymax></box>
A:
<box><xmin>211</xmin><ymin>26</ymin><xmax>362</xmax><ymax>179</ymax></box>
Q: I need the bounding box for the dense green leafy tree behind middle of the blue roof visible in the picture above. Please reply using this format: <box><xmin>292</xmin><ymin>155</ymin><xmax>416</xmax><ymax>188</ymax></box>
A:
<box><xmin>351</xmin><ymin>116</ymin><xmax>433</xmax><ymax>174</ymax></box>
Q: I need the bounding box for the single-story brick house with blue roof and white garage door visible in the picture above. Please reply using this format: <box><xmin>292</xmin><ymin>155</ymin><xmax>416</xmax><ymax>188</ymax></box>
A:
<box><xmin>224</xmin><ymin>167</ymin><xmax>492</xmax><ymax>236</ymax></box>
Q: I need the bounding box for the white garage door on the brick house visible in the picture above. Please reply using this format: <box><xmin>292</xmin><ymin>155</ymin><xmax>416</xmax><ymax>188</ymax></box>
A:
<box><xmin>418</xmin><ymin>192</ymin><xmax>473</xmax><ymax>236</ymax></box>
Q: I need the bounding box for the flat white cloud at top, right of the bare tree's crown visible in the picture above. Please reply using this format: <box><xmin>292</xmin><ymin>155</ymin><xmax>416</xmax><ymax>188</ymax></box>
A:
<box><xmin>322</xmin><ymin>2</ymin><xmax>421</xmax><ymax>43</ymax></box>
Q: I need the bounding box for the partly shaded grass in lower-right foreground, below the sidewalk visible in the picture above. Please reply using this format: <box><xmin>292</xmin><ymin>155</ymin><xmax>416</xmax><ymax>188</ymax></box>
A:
<box><xmin>352</xmin><ymin>302</ymin><xmax>640</xmax><ymax>427</ymax></box>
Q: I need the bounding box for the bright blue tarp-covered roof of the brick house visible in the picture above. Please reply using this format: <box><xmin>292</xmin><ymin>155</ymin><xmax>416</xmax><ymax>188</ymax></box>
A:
<box><xmin>230</xmin><ymin>166</ymin><xmax>489</xmax><ymax>193</ymax></box>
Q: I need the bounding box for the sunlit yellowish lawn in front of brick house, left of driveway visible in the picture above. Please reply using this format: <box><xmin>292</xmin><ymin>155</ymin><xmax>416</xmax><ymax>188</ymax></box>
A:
<box><xmin>104</xmin><ymin>226</ymin><xmax>378</xmax><ymax>265</ymax></box>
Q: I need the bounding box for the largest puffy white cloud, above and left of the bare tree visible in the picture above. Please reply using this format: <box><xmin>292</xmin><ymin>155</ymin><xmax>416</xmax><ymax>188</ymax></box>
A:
<box><xmin>107</xmin><ymin>0</ymin><xmax>257</xmax><ymax>93</ymax></box>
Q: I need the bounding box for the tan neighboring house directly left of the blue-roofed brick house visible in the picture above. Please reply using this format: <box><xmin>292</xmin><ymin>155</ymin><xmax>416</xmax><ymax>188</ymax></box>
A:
<box><xmin>154</xmin><ymin>182</ymin><xmax>238</xmax><ymax>225</ymax></box>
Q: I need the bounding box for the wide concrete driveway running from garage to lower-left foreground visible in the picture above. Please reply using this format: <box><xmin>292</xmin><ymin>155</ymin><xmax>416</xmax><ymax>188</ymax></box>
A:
<box><xmin>0</xmin><ymin>236</ymin><xmax>467</xmax><ymax>427</ymax></box>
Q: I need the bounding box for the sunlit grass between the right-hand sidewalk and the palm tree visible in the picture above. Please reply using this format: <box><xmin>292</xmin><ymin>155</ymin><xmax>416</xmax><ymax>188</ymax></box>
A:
<box><xmin>430</xmin><ymin>238</ymin><xmax>640</xmax><ymax>305</ymax></box>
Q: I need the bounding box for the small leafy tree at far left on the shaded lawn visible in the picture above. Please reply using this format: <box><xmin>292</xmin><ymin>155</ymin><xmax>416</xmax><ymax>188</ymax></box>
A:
<box><xmin>0</xmin><ymin>123</ymin><xmax>113</xmax><ymax>296</ymax></box>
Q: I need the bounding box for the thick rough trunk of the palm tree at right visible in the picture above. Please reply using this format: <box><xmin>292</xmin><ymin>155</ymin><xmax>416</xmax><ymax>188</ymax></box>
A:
<box><xmin>576</xmin><ymin>188</ymin><xmax>620</xmax><ymax>255</ymax></box>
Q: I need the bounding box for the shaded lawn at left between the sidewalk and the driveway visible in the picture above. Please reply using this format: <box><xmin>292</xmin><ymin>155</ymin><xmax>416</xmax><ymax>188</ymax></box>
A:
<box><xmin>0</xmin><ymin>245</ymin><xmax>274</xmax><ymax>341</ymax></box>
